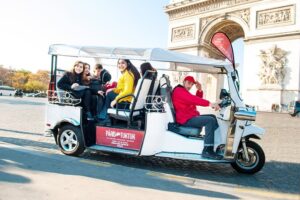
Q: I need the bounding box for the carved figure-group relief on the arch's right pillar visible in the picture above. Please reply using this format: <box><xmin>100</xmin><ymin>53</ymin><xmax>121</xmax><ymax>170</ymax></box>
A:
<box><xmin>259</xmin><ymin>45</ymin><xmax>287</xmax><ymax>85</ymax></box>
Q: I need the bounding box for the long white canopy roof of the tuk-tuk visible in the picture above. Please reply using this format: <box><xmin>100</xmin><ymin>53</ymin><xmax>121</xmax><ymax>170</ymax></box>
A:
<box><xmin>49</xmin><ymin>44</ymin><xmax>231</xmax><ymax>73</ymax></box>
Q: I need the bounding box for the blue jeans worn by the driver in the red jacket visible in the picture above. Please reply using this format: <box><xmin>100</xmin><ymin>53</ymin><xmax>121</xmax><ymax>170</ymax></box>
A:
<box><xmin>183</xmin><ymin>115</ymin><xmax>219</xmax><ymax>146</ymax></box>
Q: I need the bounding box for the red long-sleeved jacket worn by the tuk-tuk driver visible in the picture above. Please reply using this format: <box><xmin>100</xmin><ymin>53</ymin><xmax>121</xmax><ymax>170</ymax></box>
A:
<box><xmin>172</xmin><ymin>85</ymin><xmax>210</xmax><ymax>124</ymax></box>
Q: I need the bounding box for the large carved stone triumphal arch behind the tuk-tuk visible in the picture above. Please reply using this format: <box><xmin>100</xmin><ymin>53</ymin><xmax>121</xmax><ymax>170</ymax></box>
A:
<box><xmin>165</xmin><ymin>0</ymin><xmax>300</xmax><ymax>110</ymax></box>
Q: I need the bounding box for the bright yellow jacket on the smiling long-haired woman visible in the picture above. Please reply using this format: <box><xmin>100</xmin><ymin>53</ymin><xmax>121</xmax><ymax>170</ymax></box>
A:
<box><xmin>114</xmin><ymin>70</ymin><xmax>134</xmax><ymax>102</ymax></box>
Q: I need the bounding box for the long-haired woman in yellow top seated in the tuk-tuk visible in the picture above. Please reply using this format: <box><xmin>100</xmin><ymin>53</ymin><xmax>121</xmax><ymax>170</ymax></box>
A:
<box><xmin>97</xmin><ymin>59</ymin><xmax>140</xmax><ymax>123</ymax></box>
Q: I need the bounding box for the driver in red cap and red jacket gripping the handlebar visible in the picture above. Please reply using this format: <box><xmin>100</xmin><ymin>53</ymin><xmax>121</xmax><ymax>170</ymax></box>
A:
<box><xmin>172</xmin><ymin>76</ymin><xmax>222</xmax><ymax>159</ymax></box>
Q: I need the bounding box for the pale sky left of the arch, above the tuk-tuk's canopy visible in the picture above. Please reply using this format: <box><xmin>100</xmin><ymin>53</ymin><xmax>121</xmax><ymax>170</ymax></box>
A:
<box><xmin>0</xmin><ymin>0</ymin><xmax>170</xmax><ymax>72</ymax></box>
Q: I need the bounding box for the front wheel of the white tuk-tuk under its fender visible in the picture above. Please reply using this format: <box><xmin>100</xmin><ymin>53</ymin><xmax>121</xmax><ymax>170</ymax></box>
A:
<box><xmin>231</xmin><ymin>141</ymin><xmax>265</xmax><ymax>174</ymax></box>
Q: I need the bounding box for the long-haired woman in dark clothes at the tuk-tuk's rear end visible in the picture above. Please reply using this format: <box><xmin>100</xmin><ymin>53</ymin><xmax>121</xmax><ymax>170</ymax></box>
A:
<box><xmin>57</xmin><ymin>61</ymin><xmax>94</xmax><ymax>120</ymax></box>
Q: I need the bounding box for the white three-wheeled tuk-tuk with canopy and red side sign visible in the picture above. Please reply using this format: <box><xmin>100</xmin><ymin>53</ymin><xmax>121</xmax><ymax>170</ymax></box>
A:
<box><xmin>46</xmin><ymin>45</ymin><xmax>265</xmax><ymax>174</ymax></box>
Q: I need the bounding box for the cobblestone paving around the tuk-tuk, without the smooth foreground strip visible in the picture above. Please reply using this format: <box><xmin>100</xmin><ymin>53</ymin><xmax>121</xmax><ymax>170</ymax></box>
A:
<box><xmin>0</xmin><ymin>97</ymin><xmax>300</xmax><ymax>199</ymax></box>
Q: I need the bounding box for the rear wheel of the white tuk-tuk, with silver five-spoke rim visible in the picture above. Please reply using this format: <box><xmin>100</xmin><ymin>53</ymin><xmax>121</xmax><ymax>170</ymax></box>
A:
<box><xmin>57</xmin><ymin>125</ymin><xmax>85</xmax><ymax>156</ymax></box>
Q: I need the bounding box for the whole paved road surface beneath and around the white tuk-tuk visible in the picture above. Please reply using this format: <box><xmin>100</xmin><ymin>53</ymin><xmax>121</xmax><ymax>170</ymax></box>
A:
<box><xmin>0</xmin><ymin>97</ymin><xmax>300</xmax><ymax>200</ymax></box>
